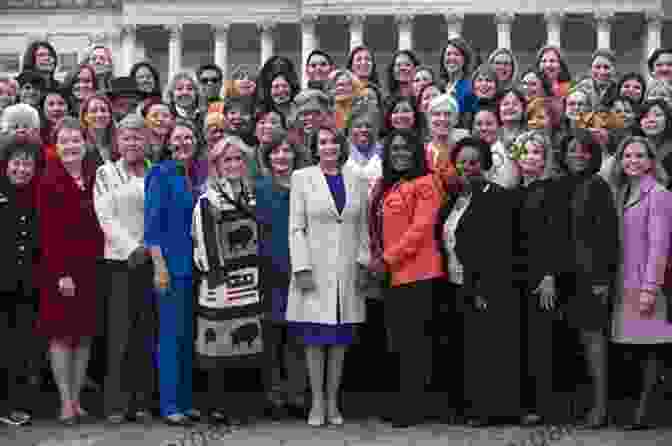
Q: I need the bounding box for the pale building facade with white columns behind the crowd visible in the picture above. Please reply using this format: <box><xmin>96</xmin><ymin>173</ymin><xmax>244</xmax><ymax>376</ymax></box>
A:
<box><xmin>0</xmin><ymin>0</ymin><xmax>672</xmax><ymax>86</ymax></box>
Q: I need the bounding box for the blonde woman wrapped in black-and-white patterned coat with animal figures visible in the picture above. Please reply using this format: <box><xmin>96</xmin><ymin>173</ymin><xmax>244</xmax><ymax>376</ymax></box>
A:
<box><xmin>192</xmin><ymin>135</ymin><xmax>266</xmax><ymax>425</ymax></box>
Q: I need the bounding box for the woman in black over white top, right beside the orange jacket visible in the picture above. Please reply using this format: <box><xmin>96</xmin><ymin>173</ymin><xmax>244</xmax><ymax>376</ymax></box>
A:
<box><xmin>436</xmin><ymin>138</ymin><xmax>520</xmax><ymax>426</ymax></box>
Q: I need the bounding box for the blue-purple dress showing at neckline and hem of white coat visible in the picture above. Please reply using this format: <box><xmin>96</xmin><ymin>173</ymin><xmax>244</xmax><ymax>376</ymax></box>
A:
<box><xmin>289</xmin><ymin>174</ymin><xmax>355</xmax><ymax>345</ymax></box>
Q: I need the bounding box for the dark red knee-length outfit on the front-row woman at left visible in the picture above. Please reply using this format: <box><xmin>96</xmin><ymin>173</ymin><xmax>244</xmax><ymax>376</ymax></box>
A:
<box><xmin>37</xmin><ymin>158</ymin><xmax>104</xmax><ymax>338</ymax></box>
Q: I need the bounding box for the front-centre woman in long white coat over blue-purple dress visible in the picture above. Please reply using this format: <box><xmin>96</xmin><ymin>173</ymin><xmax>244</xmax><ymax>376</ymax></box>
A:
<box><xmin>287</xmin><ymin>127</ymin><xmax>369</xmax><ymax>426</ymax></box>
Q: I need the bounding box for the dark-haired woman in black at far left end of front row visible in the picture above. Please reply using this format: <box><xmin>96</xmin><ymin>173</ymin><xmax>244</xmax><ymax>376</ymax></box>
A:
<box><xmin>0</xmin><ymin>144</ymin><xmax>40</xmax><ymax>426</ymax></box>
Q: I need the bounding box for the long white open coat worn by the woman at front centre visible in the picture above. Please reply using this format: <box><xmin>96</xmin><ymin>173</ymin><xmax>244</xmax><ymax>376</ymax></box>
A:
<box><xmin>287</xmin><ymin>165</ymin><xmax>369</xmax><ymax>324</ymax></box>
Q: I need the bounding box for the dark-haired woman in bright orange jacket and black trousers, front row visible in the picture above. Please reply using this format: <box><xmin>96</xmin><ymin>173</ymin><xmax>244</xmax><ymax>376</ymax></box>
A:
<box><xmin>369</xmin><ymin>129</ymin><xmax>456</xmax><ymax>427</ymax></box>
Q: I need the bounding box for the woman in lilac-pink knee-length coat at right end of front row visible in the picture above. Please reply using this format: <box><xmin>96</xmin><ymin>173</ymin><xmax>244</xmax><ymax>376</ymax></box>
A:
<box><xmin>608</xmin><ymin>136</ymin><xmax>672</xmax><ymax>429</ymax></box>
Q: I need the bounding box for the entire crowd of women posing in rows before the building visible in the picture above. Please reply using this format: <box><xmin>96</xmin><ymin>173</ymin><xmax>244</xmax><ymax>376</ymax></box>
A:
<box><xmin>0</xmin><ymin>33</ymin><xmax>672</xmax><ymax>428</ymax></box>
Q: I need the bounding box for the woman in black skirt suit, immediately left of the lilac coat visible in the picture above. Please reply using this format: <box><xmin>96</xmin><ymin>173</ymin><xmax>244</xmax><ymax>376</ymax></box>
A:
<box><xmin>558</xmin><ymin>129</ymin><xmax>620</xmax><ymax>428</ymax></box>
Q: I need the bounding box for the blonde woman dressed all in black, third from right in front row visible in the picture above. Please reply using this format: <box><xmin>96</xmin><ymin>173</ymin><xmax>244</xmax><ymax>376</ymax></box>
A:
<box><xmin>512</xmin><ymin>130</ymin><xmax>564</xmax><ymax>424</ymax></box>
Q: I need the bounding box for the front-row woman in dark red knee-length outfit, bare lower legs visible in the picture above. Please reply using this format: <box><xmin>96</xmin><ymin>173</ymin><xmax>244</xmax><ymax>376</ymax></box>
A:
<box><xmin>37</xmin><ymin>117</ymin><xmax>104</xmax><ymax>425</ymax></box>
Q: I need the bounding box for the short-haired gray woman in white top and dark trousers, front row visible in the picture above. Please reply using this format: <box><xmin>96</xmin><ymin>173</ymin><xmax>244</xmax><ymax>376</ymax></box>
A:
<box><xmin>94</xmin><ymin>114</ymin><xmax>156</xmax><ymax>424</ymax></box>
